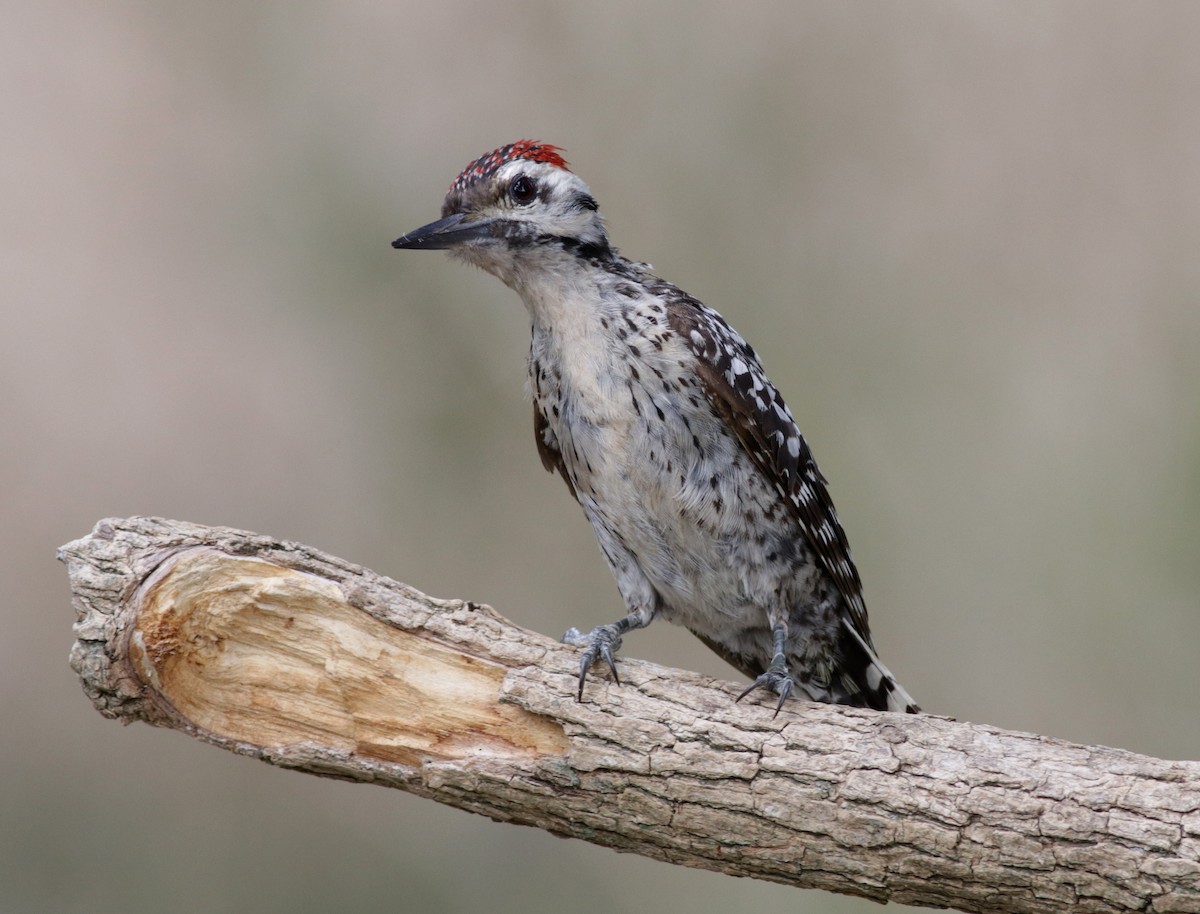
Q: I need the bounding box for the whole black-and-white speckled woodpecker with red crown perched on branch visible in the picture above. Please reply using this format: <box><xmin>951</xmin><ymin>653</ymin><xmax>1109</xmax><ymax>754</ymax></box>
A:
<box><xmin>392</xmin><ymin>140</ymin><xmax>919</xmax><ymax>714</ymax></box>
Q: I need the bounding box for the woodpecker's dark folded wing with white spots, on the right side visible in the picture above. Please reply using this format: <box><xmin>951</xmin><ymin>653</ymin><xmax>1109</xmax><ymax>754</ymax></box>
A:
<box><xmin>662</xmin><ymin>283</ymin><xmax>871</xmax><ymax>645</ymax></box>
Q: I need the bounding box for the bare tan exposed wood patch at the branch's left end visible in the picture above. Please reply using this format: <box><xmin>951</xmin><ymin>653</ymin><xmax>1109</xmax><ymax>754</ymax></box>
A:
<box><xmin>128</xmin><ymin>547</ymin><xmax>566</xmax><ymax>765</ymax></box>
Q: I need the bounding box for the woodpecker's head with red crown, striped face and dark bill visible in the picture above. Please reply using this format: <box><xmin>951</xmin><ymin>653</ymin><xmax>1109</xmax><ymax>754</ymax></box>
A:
<box><xmin>391</xmin><ymin>139</ymin><xmax>610</xmax><ymax>285</ymax></box>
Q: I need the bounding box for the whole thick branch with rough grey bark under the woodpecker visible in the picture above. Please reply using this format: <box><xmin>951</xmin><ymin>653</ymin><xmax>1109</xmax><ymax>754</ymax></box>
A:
<box><xmin>60</xmin><ymin>517</ymin><xmax>1200</xmax><ymax>914</ymax></box>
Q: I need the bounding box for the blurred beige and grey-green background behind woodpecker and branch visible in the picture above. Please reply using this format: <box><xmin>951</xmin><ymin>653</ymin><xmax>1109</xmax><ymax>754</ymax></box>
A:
<box><xmin>7</xmin><ymin>0</ymin><xmax>1200</xmax><ymax>914</ymax></box>
